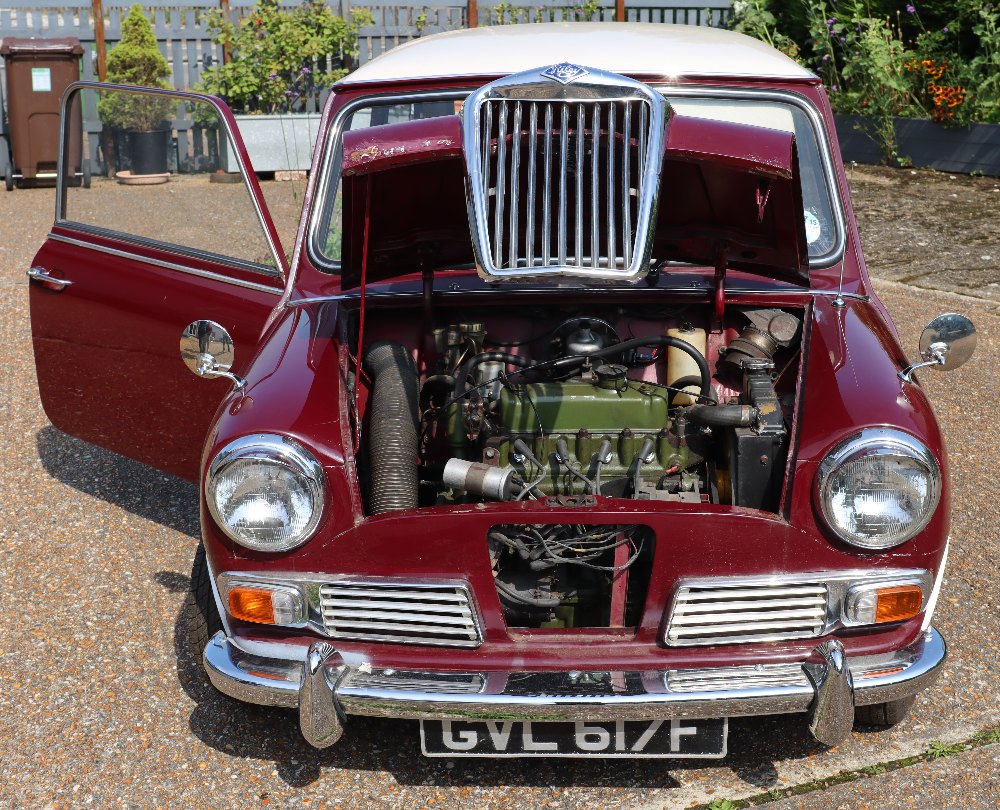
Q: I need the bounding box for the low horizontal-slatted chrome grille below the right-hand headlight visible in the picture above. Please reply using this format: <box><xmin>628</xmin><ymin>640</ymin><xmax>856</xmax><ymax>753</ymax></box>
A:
<box><xmin>666</xmin><ymin>582</ymin><xmax>828</xmax><ymax>646</ymax></box>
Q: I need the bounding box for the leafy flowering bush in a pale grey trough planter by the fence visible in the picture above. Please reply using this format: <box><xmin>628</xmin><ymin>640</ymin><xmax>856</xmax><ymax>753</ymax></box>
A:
<box><xmin>198</xmin><ymin>0</ymin><xmax>373</xmax><ymax>171</ymax></box>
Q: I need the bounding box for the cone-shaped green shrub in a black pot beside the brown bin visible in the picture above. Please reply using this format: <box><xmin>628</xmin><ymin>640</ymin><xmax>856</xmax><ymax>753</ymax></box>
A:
<box><xmin>98</xmin><ymin>3</ymin><xmax>176</xmax><ymax>175</ymax></box>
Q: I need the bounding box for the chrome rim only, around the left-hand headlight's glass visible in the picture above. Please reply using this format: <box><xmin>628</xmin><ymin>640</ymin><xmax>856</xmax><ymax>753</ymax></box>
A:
<box><xmin>203</xmin><ymin>433</ymin><xmax>327</xmax><ymax>554</ymax></box>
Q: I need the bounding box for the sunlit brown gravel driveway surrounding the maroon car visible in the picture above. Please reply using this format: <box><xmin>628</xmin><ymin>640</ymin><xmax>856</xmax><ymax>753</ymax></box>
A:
<box><xmin>0</xmin><ymin>167</ymin><xmax>1000</xmax><ymax>808</ymax></box>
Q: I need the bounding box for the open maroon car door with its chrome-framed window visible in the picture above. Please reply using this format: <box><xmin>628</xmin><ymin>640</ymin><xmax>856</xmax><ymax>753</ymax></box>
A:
<box><xmin>28</xmin><ymin>82</ymin><xmax>287</xmax><ymax>480</ymax></box>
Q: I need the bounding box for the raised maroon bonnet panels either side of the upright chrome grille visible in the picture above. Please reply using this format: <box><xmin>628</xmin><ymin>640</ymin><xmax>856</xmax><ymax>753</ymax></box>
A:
<box><xmin>342</xmin><ymin>104</ymin><xmax>809</xmax><ymax>288</ymax></box>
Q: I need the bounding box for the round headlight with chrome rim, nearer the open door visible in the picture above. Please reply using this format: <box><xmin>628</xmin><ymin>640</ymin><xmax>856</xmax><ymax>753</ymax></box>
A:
<box><xmin>205</xmin><ymin>433</ymin><xmax>326</xmax><ymax>551</ymax></box>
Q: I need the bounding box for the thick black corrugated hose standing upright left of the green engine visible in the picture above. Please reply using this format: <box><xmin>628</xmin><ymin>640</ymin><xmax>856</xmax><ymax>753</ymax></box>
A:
<box><xmin>364</xmin><ymin>340</ymin><xmax>418</xmax><ymax>515</ymax></box>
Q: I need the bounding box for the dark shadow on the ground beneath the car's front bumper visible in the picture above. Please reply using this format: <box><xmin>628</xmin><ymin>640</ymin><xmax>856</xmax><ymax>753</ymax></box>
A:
<box><xmin>161</xmin><ymin>583</ymin><xmax>821</xmax><ymax>790</ymax></box>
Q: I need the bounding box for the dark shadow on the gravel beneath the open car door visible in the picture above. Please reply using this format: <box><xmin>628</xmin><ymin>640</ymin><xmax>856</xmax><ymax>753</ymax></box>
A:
<box><xmin>35</xmin><ymin>425</ymin><xmax>199</xmax><ymax>538</ymax></box>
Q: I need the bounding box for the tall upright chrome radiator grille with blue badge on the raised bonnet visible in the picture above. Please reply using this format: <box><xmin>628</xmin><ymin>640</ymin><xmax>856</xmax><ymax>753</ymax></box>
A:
<box><xmin>463</xmin><ymin>64</ymin><xmax>669</xmax><ymax>281</ymax></box>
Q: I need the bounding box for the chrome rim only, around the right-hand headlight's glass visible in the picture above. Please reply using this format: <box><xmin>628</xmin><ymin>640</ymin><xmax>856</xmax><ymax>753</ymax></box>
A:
<box><xmin>813</xmin><ymin>425</ymin><xmax>944</xmax><ymax>553</ymax></box>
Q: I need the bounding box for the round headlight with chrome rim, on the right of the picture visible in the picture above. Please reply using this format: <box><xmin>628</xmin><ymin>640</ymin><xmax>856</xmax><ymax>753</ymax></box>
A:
<box><xmin>816</xmin><ymin>428</ymin><xmax>941</xmax><ymax>549</ymax></box>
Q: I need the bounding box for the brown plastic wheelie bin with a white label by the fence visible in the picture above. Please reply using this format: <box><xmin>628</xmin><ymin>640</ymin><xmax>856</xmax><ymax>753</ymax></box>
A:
<box><xmin>0</xmin><ymin>37</ymin><xmax>90</xmax><ymax>191</ymax></box>
